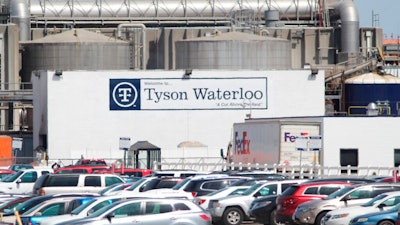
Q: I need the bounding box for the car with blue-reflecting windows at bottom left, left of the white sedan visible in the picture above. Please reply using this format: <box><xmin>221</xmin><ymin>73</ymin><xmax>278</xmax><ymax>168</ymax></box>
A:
<box><xmin>16</xmin><ymin>197</ymin><xmax>93</xmax><ymax>225</ymax></box>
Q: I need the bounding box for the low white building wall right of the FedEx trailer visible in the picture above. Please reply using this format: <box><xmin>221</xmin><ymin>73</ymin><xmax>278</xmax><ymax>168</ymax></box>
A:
<box><xmin>322</xmin><ymin>117</ymin><xmax>400</xmax><ymax>167</ymax></box>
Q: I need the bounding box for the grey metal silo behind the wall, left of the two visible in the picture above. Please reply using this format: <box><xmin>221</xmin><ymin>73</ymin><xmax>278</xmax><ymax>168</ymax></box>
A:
<box><xmin>21</xmin><ymin>29</ymin><xmax>130</xmax><ymax>81</ymax></box>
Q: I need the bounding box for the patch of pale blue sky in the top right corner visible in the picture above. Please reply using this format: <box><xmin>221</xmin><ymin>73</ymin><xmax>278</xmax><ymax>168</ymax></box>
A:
<box><xmin>353</xmin><ymin>0</ymin><xmax>400</xmax><ymax>38</ymax></box>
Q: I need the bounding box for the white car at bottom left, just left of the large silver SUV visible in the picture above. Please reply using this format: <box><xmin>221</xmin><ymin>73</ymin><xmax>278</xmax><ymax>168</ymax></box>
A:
<box><xmin>40</xmin><ymin>196</ymin><xmax>130</xmax><ymax>225</ymax></box>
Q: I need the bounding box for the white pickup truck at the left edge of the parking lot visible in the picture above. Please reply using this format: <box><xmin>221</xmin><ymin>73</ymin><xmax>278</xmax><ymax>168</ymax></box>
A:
<box><xmin>0</xmin><ymin>168</ymin><xmax>53</xmax><ymax>194</ymax></box>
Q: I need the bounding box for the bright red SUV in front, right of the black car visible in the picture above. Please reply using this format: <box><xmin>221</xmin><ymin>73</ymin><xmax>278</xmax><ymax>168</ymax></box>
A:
<box><xmin>276</xmin><ymin>181</ymin><xmax>353</xmax><ymax>224</ymax></box>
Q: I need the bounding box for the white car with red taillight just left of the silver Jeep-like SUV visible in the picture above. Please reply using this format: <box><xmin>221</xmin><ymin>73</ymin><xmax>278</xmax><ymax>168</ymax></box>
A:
<box><xmin>194</xmin><ymin>186</ymin><xmax>250</xmax><ymax>209</ymax></box>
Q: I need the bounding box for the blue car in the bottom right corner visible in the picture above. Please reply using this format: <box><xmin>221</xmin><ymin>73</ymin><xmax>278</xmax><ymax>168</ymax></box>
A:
<box><xmin>349</xmin><ymin>204</ymin><xmax>400</xmax><ymax>225</ymax></box>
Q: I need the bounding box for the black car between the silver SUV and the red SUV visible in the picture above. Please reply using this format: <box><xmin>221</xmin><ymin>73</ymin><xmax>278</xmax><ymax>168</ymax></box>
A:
<box><xmin>249</xmin><ymin>195</ymin><xmax>278</xmax><ymax>225</ymax></box>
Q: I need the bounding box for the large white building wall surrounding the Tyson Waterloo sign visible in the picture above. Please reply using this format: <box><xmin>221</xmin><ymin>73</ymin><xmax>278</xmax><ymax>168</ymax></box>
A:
<box><xmin>32</xmin><ymin>70</ymin><xmax>325</xmax><ymax>159</ymax></box>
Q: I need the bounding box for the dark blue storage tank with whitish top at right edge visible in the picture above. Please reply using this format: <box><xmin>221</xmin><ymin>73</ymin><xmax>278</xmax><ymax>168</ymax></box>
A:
<box><xmin>344</xmin><ymin>72</ymin><xmax>400</xmax><ymax>115</ymax></box>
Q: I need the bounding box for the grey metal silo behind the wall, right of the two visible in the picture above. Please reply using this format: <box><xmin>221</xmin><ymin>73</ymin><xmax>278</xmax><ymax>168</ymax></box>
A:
<box><xmin>175</xmin><ymin>32</ymin><xmax>292</xmax><ymax>70</ymax></box>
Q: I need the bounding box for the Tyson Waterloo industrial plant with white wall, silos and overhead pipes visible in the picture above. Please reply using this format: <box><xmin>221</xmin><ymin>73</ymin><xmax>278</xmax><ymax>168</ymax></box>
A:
<box><xmin>0</xmin><ymin>0</ymin><xmax>400</xmax><ymax>171</ymax></box>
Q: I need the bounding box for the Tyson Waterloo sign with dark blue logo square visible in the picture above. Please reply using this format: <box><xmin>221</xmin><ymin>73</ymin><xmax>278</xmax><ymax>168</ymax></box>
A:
<box><xmin>110</xmin><ymin>77</ymin><xmax>267</xmax><ymax>110</ymax></box>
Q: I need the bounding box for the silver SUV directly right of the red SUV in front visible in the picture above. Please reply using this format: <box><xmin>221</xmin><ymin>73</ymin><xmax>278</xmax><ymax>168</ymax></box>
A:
<box><xmin>292</xmin><ymin>183</ymin><xmax>400</xmax><ymax>225</ymax></box>
